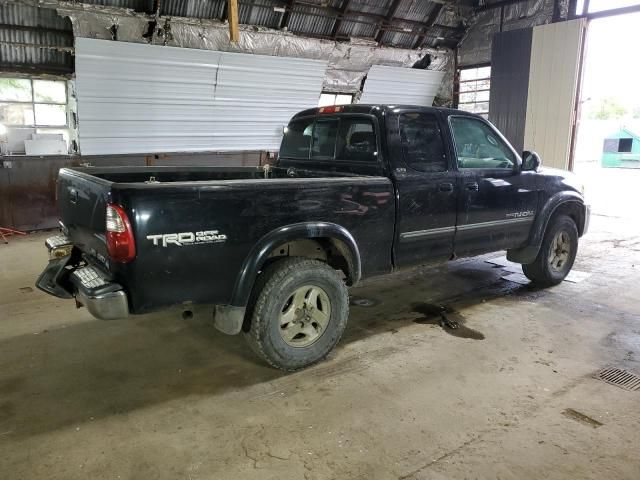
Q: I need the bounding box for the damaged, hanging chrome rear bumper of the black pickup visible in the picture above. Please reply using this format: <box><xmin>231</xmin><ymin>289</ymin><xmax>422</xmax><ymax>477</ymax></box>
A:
<box><xmin>36</xmin><ymin>236</ymin><xmax>129</xmax><ymax>320</ymax></box>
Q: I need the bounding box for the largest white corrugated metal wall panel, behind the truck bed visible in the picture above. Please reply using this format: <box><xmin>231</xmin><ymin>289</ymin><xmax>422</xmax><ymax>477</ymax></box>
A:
<box><xmin>76</xmin><ymin>38</ymin><xmax>327</xmax><ymax>155</ymax></box>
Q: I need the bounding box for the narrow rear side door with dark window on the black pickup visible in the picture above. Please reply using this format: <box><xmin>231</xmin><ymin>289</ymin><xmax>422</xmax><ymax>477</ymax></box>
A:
<box><xmin>392</xmin><ymin>112</ymin><xmax>459</xmax><ymax>267</ymax></box>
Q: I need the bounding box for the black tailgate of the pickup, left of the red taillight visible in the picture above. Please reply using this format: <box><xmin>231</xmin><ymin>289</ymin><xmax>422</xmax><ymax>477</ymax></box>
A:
<box><xmin>57</xmin><ymin>168</ymin><xmax>111</xmax><ymax>264</ymax></box>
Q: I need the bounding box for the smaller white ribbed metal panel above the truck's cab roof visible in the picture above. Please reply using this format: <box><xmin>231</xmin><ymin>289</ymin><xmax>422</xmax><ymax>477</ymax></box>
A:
<box><xmin>360</xmin><ymin>65</ymin><xmax>444</xmax><ymax>106</ymax></box>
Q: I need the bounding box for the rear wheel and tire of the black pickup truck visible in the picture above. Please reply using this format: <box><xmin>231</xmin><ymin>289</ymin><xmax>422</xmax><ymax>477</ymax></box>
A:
<box><xmin>244</xmin><ymin>257</ymin><xmax>349</xmax><ymax>371</ymax></box>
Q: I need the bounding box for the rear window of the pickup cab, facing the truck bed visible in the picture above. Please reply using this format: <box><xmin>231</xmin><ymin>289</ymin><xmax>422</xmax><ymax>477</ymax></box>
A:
<box><xmin>280</xmin><ymin>114</ymin><xmax>378</xmax><ymax>164</ymax></box>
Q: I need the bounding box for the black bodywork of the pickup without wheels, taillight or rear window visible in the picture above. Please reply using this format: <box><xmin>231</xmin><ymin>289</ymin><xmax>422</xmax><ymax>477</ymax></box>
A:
<box><xmin>39</xmin><ymin>105</ymin><xmax>588</xmax><ymax>333</ymax></box>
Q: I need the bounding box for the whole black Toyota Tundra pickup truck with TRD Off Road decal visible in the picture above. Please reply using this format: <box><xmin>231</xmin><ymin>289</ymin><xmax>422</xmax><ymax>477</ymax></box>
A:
<box><xmin>37</xmin><ymin>105</ymin><xmax>589</xmax><ymax>370</ymax></box>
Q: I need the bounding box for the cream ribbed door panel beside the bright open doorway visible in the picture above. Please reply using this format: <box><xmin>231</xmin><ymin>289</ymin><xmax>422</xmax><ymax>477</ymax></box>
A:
<box><xmin>524</xmin><ymin>19</ymin><xmax>586</xmax><ymax>169</ymax></box>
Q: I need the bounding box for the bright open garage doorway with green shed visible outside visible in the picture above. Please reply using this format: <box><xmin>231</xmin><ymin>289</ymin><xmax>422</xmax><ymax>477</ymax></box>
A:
<box><xmin>574</xmin><ymin>0</ymin><xmax>640</xmax><ymax>219</ymax></box>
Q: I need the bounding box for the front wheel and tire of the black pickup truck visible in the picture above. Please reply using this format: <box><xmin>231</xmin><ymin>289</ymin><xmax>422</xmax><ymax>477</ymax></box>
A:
<box><xmin>522</xmin><ymin>215</ymin><xmax>578</xmax><ymax>287</ymax></box>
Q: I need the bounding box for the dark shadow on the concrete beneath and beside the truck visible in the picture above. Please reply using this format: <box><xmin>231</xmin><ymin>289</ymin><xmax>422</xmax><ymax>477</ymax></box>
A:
<box><xmin>0</xmin><ymin>261</ymin><xmax>544</xmax><ymax>441</ymax></box>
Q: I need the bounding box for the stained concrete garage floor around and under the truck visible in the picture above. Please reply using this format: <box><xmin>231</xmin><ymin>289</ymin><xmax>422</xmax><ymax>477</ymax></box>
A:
<box><xmin>0</xmin><ymin>177</ymin><xmax>640</xmax><ymax>480</ymax></box>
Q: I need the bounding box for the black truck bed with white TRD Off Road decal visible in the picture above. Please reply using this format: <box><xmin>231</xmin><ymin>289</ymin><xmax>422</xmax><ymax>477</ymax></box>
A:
<box><xmin>58</xmin><ymin>167</ymin><xmax>395</xmax><ymax>313</ymax></box>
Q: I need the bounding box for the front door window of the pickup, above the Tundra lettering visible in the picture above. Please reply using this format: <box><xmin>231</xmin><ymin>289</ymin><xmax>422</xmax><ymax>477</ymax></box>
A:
<box><xmin>449</xmin><ymin>117</ymin><xmax>516</xmax><ymax>170</ymax></box>
